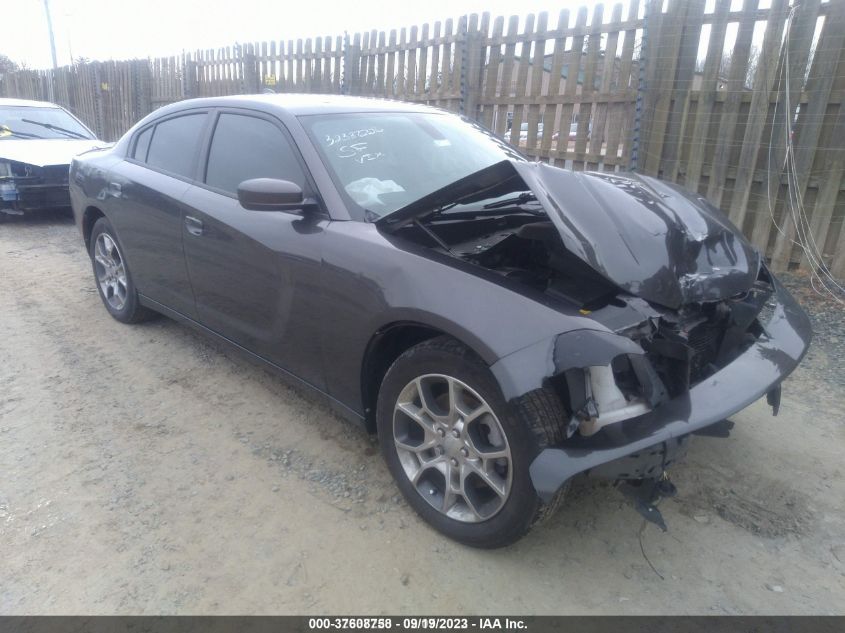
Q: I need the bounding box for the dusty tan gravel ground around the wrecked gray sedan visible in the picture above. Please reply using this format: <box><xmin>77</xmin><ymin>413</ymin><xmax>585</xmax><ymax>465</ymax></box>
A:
<box><xmin>0</xmin><ymin>216</ymin><xmax>845</xmax><ymax>614</ymax></box>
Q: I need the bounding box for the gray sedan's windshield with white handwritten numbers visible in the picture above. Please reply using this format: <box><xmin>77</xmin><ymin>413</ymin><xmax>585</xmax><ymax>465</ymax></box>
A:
<box><xmin>300</xmin><ymin>112</ymin><xmax>524</xmax><ymax>221</ymax></box>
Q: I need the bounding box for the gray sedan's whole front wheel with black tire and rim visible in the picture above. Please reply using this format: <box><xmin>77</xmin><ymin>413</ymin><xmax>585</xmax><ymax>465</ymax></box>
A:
<box><xmin>376</xmin><ymin>337</ymin><xmax>564</xmax><ymax>548</ymax></box>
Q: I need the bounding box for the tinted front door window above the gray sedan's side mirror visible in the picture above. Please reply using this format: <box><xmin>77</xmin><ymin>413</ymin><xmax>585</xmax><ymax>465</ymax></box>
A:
<box><xmin>205</xmin><ymin>114</ymin><xmax>305</xmax><ymax>193</ymax></box>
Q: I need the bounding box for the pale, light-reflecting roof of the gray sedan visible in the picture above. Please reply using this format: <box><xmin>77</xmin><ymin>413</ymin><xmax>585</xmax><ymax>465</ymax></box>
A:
<box><xmin>157</xmin><ymin>93</ymin><xmax>441</xmax><ymax>116</ymax></box>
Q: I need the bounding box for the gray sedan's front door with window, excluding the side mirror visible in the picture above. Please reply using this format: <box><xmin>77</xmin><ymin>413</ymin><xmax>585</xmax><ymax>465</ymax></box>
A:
<box><xmin>183</xmin><ymin>109</ymin><xmax>328</xmax><ymax>389</ymax></box>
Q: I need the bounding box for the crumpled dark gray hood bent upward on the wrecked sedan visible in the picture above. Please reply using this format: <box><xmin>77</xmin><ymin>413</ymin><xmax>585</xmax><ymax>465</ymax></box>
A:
<box><xmin>511</xmin><ymin>161</ymin><xmax>760</xmax><ymax>308</ymax></box>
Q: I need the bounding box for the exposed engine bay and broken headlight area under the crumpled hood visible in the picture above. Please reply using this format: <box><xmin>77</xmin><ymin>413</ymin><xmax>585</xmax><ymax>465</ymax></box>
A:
<box><xmin>390</xmin><ymin>205</ymin><xmax>773</xmax><ymax>439</ymax></box>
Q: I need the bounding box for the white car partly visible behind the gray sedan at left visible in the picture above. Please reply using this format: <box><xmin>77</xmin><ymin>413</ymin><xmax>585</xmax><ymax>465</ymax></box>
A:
<box><xmin>0</xmin><ymin>99</ymin><xmax>106</xmax><ymax>221</ymax></box>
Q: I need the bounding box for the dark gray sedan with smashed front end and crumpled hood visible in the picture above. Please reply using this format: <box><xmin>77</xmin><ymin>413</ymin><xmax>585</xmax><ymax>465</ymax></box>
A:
<box><xmin>71</xmin><ymin>95</ymin><xmax>810</xmax><ymax>547</ymax></box>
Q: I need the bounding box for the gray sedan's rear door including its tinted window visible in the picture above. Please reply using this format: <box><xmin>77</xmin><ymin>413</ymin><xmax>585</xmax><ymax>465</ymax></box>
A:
<box><xmin>105</xmin><ymin>111</ymin><xmax>209</xmax><ymax>318</ymax></box>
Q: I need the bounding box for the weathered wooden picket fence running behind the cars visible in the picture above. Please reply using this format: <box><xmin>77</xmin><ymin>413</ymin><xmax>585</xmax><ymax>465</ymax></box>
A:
<box><xmin>0</xmin><ymin>0</ymin><xmax>845</xmax><ymax>278</ymax></box>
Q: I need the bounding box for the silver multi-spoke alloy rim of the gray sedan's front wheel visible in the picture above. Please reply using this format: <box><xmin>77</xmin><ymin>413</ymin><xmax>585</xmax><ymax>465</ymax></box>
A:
<box><xmin>393</xmin><ymin>374</ymin><xmax>513</xmax><ymax>523</ymax></box>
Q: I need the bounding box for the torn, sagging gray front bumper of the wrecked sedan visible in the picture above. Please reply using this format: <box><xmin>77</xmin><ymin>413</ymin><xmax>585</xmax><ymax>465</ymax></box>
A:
<box><xmin>530</xmin><ymin>280</ymin><xmax>811</xmax><ymax>500</ymax></box>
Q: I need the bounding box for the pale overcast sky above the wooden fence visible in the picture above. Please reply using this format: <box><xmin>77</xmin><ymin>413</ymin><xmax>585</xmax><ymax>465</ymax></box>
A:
<box><xmin>6</xmin><ymin>0</ymin><xmax>628</xmax><ymax>68</ymax></box>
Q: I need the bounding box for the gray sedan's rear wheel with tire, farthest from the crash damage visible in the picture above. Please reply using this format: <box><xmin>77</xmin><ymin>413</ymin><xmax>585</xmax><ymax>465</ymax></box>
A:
<box><xmin>88</xmin><ymin>218</ymin><xmax>156</xmax><ymax>323</ymax></box>
